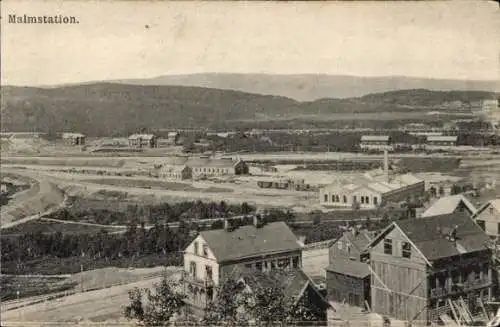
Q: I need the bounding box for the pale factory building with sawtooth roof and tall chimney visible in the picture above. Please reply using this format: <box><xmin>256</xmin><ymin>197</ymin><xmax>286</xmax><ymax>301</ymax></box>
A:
<box><xmin>319</xmin><ymin>150</ymin><xmax>425</xmax><ymax>209</ymax></box>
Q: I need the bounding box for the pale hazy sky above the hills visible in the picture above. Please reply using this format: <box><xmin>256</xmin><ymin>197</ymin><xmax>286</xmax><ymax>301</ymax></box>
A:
<box><xmin>1</xmin><ymin>0</ymin><xmax>500</xmax><ymax>85</ymax></box>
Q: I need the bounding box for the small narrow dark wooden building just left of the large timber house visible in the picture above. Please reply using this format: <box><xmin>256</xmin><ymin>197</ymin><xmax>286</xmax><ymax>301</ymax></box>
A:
<box><xmin>326</xmin><ymin>227</ymin><xmax>373</xmax><ymax>307</ymax></box>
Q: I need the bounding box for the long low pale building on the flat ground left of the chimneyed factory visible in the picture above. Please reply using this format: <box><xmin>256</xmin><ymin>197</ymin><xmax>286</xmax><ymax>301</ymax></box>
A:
<box><xmin>158</xmin><ymin>157</ymin><xmax>249</xmax><ymax>180</ymax></box>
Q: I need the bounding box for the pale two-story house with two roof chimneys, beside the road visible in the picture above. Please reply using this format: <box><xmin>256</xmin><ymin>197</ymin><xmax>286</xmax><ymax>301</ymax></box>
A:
<box><xmin>183</xmin><ymin>218</ymin><xmax>302</xmax><ymax>314</ymax></box>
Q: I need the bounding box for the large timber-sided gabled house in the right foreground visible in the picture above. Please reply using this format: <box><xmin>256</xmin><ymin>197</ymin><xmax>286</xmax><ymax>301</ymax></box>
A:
<box><xmin>368</xmin><ymin>212</ymin><xmax>494</xmax><ymax>324</ymax></box>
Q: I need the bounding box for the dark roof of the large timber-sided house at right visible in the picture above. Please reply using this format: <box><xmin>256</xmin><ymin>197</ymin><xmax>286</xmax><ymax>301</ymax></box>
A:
<box><xmin>395</xmin><ymin>212</ymin><xmax>489</xmax><ymax>261</ymax></box>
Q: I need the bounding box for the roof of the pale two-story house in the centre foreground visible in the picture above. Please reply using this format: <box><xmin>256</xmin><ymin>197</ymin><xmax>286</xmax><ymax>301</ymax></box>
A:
<box><xmin>200</xmin><ymin>222</ymin><xmax>301</xmax><ymax>262</ymax></box>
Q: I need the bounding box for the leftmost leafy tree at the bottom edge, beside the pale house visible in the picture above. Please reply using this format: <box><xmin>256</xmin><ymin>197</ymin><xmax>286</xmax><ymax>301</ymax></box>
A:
<box><xmin>124</xmin><ymin>278</ymin><xmax>185</xmax><ymax>327</ymax></box>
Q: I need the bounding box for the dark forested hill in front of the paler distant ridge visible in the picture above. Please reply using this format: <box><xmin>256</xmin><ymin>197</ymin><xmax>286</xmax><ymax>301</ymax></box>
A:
<box><xmin>2</xmin><ymin>83</ymin><xmax>498</xmax><ymax>135</ymax></box>
